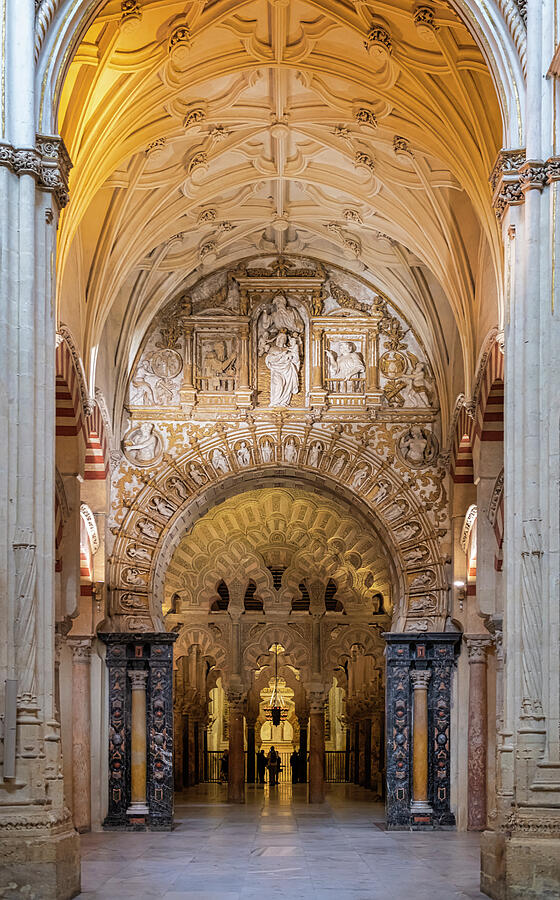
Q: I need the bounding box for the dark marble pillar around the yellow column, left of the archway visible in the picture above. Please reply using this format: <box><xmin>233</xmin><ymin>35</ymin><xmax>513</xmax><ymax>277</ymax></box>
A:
<box><xmin>99</xmin><ymin>632</ymin><xmax>177</xmax><ymax>831</ymax></box>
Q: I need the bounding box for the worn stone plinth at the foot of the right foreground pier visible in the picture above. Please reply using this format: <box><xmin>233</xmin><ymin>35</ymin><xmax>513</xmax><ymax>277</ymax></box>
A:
<box><xmin>480</xmin><ymin>811</ymin><xmax>560</xmax><ymax>900</ymax></box>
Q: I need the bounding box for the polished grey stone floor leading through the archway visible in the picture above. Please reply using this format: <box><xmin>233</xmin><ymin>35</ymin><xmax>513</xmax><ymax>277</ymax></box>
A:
<box><xmin>79</xmin><ymin>784</ymin><xmax>484</xmax><ymax>900</ymax></box>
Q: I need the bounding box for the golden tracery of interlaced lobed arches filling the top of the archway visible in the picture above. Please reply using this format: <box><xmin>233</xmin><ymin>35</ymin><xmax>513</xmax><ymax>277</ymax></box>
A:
<box><xmin>165</xmin><ymin>488</ymin><xmax>391</xmax><ymax>615</ymax></box>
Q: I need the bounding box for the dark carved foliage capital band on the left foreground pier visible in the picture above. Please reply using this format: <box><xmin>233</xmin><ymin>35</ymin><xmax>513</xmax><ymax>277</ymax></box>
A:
<box><xmin>0</xmin><ymin>134</ymin><xmax>72</xmax><ymax>209</ymax></box>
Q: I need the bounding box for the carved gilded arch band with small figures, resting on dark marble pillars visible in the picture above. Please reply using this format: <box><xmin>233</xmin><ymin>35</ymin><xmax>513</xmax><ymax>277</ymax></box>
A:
<box><xmin>109</xmin><ymin>414</ymin><xmax>450</xmax><ymax>632</ymax></box>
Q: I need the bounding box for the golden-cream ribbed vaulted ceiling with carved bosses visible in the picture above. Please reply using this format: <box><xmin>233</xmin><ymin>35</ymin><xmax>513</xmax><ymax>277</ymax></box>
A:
<box><xmin>58</xmin><ymin>0</ymin><xmax>501</xmax><ymax>412</ymax></box>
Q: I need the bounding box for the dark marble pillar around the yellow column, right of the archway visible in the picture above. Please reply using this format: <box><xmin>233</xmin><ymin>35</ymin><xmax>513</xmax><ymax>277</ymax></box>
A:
<box><xmin>383</xmin><ymin>632</ymin><xmax>462</xmax><ymax>831</ymax></box>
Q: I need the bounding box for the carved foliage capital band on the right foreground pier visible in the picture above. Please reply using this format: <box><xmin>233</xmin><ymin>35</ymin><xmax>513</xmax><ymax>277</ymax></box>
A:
<box><xmin>489</xmin><ymin>149</ymin><xmax>560</xmax><ymax>222</ymax></box>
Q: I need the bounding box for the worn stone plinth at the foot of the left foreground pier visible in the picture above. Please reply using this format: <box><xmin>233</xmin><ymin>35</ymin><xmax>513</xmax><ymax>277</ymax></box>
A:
<box><xmin>0</xmin><ymin>816</ymin><xmax>80</xmax><ymax>900</ymax></box>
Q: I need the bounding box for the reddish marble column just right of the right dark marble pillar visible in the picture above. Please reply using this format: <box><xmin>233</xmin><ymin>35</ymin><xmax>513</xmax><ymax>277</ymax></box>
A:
<box><xmin>466</xmin><ymin>637</ymin><xmax>490</xmax><ymax>831</ymax></box>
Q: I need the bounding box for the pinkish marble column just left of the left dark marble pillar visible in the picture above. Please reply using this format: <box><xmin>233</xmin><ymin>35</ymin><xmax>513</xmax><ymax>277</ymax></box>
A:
<box><xmin>68</xmin><ymin>639</ymin><xmax>91</xmax><ymax>832</ymax></box>
